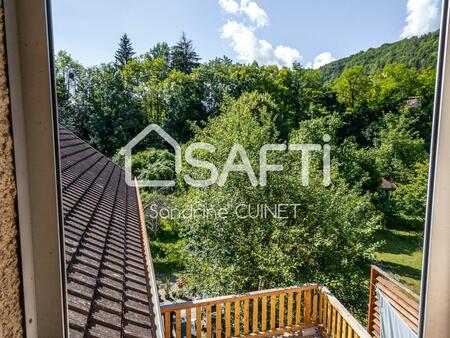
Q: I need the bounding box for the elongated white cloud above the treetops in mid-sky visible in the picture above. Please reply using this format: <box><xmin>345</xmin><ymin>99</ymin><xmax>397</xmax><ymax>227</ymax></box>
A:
<box><xmin>222</xmin><ymin>20</ymin><xmax>301</xmax><ymax>67</ymax></box>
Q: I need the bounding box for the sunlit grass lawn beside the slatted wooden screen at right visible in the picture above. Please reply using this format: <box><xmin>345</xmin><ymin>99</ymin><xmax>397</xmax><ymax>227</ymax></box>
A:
<box><xmin>376</xmin><ymin>229</ymin><xmax>423</xmax><ymax>294</ymax></box>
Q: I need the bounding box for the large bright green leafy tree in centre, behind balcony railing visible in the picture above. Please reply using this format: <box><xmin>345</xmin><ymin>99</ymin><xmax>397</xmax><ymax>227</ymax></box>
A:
<box><xmin>176</xmin><ymin>93</ymin><xmax>378</xmax><ymax>313</ymax></box>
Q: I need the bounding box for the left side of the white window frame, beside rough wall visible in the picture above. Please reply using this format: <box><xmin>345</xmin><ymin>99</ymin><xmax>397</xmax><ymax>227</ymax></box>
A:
<box><xmin>3</xmin><ymin>0</ymin><xmax>68</xmax><ymax>338</ymax></box>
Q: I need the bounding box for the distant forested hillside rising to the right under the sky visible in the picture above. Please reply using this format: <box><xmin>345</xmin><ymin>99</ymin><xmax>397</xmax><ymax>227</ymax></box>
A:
<box><xmin>320</xmin><ymin>31</ymin><xmax>439</xmax><ymax>81</ymax></box>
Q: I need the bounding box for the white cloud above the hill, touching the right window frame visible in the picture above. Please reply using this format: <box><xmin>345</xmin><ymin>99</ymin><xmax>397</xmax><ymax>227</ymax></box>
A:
<box><xmin>401</xmin><ymin>0</ymin><xmax>439</xmax><ymax>38</ymax></box>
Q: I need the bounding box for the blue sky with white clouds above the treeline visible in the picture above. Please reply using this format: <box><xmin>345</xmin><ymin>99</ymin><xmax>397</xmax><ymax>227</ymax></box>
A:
<box><xmin>52</xmin><ymin>0</ymin><xmax>441</xmax><ymax>67</ymax></box>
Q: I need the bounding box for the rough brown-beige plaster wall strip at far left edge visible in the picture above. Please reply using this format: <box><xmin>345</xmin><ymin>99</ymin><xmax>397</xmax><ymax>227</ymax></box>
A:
<box><xmin>0</xmin><ymin>0</ymin><xmax>23</xmax><ymax>337</ymax></box>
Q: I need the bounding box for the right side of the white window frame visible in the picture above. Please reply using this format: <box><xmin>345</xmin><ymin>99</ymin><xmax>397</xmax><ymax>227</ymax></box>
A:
<box><xmin>419</xmin><ymin>0</ymin><xmax>450</xmax><ymax>338</ymax></box>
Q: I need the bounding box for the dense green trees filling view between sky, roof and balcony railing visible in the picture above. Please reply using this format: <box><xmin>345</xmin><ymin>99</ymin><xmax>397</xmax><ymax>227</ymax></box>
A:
<box><xmin>56</xmin><ymin>33</ymin><xmax>437</xmax><ymax>317</ymax></box>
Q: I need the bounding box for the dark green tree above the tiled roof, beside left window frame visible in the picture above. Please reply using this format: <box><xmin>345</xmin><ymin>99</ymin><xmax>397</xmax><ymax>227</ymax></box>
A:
<box><xmin>56</xmin><ymin>52</ymin><xmax>146</xmax><ymax>156</ymax></box>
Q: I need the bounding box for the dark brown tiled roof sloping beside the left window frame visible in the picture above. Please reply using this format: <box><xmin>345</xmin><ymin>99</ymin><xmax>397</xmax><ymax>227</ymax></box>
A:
<box><xmin>60</xmin><ymin>128</ymin><xmax>154</xmax><ymax>338</ymax></box>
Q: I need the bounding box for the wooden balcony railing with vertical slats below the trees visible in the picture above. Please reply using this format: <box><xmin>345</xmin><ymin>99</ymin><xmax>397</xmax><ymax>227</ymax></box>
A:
<box><xmin>161</xmin><ymin>284</ymin><xmax>369</xmax><ymax>338</ymax></box>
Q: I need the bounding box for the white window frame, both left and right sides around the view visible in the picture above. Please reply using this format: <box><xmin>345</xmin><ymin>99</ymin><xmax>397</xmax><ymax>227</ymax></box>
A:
<box><xmin>4</xmin><ymin>0</ymin><xmax>450</xmax><ymax>338</ymax></box>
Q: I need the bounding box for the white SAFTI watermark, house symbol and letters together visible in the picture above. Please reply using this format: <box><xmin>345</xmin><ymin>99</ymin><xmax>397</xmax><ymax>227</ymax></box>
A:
<box><xmin>121</xmin><ymin>124</ymin><xmax>331</xmax><ymax>188</ymax></box>
